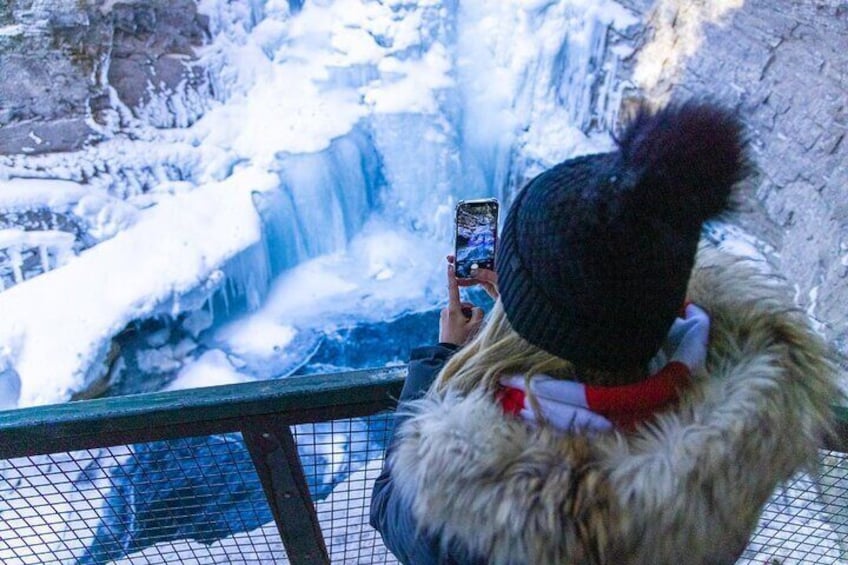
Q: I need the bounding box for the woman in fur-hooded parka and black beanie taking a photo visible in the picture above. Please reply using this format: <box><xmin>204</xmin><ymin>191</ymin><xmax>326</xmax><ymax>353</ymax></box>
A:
<box><xmin>371</xmin><ymin>101</ymin><xmax>840</xmax><ymax>564</ymax></box>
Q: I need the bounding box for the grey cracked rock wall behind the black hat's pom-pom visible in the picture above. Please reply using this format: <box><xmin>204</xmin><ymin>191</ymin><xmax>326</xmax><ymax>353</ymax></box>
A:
<box><xmin>625</xmin><ymin>0</ymin><xmax>848</xmax><ymax>362</ymax></box>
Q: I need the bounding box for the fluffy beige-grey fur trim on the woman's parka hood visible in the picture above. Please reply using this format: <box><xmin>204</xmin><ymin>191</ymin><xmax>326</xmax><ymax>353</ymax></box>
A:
<box><xmin>391</xmin><ymin>246</ymin><xmax>839</xmax><ymax>564</ymax></box>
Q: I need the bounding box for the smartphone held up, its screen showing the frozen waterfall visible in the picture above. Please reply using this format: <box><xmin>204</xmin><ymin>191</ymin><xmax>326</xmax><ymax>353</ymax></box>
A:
<box><xmin>454</xmin><ymin>198</ymin><xmax>499</xmax><ymax>279</ymax></box>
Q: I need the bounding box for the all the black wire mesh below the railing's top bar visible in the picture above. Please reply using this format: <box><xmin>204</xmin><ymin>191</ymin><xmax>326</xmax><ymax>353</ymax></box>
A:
<box><xmin>0</xmin><ymin>413</ymin><xmax>848</xmax><ymax>565</ymax></box>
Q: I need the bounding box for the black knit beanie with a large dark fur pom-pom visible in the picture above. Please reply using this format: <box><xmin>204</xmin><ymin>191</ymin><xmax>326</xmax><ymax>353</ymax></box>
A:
<box><xmin>496</xmin><ymin>102</ymin><xmax>746</xmax><ymax>370</ymax></box>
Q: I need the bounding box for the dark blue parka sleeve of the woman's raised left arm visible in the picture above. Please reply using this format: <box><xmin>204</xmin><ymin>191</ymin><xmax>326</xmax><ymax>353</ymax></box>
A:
<box><xmin>371</xmin><ymin>344</ymin><xmax>457</xmax><ymax>564</ymax></box>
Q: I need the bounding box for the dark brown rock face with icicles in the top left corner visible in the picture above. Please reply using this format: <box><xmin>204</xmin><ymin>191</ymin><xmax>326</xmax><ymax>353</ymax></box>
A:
<box><xmin>0</xmin><ymin>0</ymin><xmax>208</xmax><ymax>154</ymax></box>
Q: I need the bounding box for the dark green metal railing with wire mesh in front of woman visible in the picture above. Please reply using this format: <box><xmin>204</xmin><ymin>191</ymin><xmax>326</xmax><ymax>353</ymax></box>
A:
<box><xmin>0</xmin><ymin>368</ymin><xmax>848</xmax><ymax>565</ymax></box>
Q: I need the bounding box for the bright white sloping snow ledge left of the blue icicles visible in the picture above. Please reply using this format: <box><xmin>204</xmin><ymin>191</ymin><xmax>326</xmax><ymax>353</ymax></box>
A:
<box><xmin>0</xmin><ymin>166</ymin><xmax>276</xmax><ymax>406</ymax></box>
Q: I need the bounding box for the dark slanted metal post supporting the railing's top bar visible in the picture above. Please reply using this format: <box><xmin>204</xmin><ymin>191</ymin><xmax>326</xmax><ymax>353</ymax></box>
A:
<box><xmin>242</xmin><ymin>418</ymin><xmax>330</xmax><ymax>565</ymax></box>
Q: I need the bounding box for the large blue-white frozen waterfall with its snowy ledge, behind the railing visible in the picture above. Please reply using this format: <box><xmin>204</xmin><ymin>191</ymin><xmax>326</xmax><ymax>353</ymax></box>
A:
<box><xmin>0</xmin><ymin>0</ymin><xmax>635</xmax><ymax>405</ymax></box>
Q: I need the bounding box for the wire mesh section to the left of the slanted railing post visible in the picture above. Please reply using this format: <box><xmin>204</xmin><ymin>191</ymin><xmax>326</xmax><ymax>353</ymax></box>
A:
<box><xmin>0</xmin><ymin>434</ymin><xmax>279</xmax><ymax>565</ymax></box>
